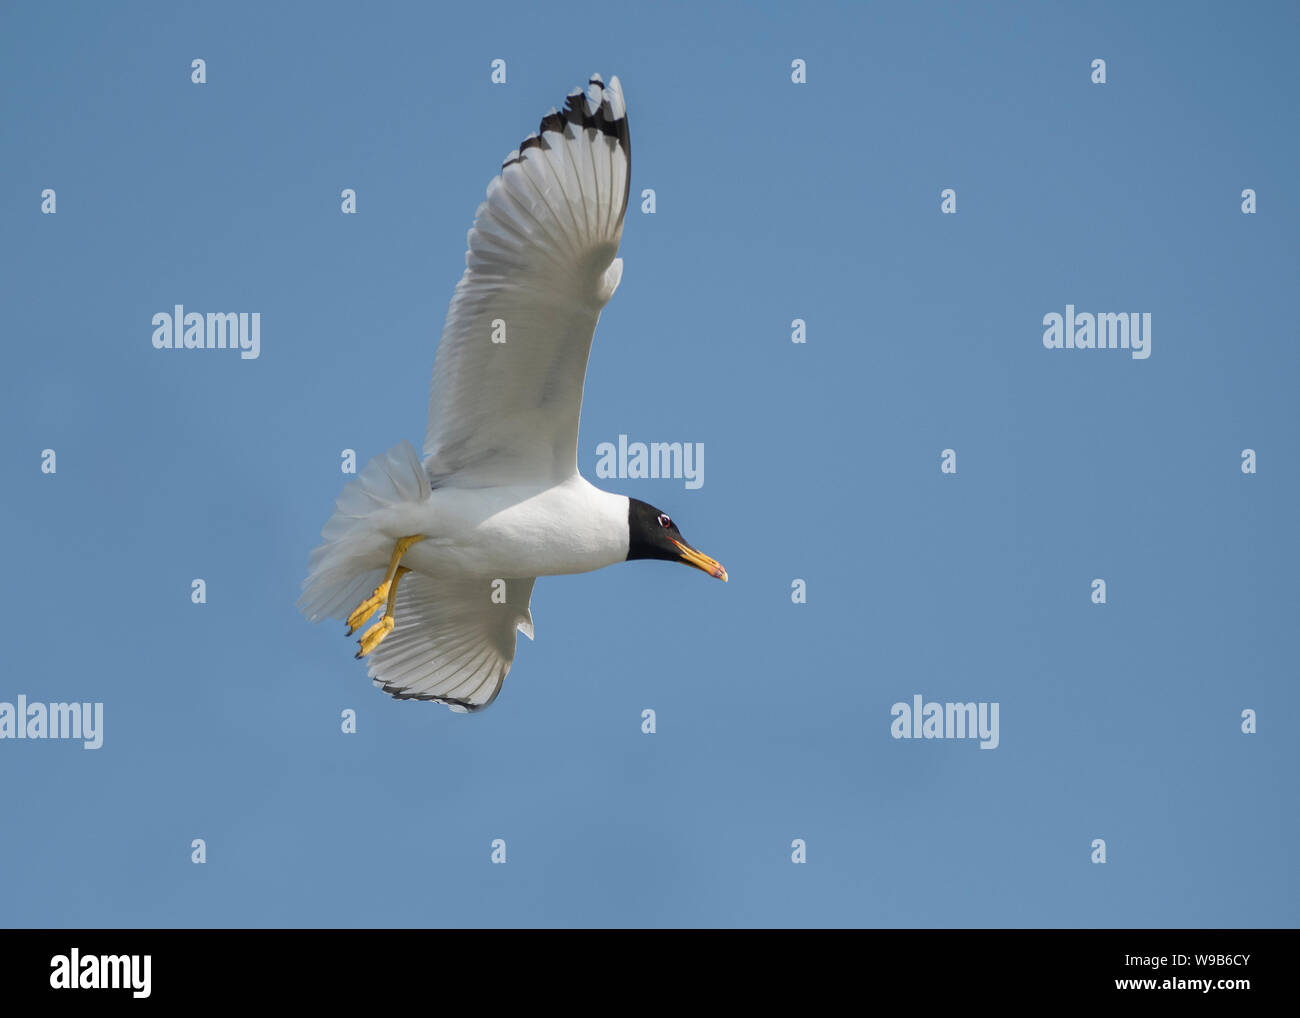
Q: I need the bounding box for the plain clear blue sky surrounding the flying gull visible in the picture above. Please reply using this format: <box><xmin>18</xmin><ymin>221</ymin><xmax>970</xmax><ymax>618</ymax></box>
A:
<box><xmin>0</xmin><ymin>3</ymin><xmax>1300</xmax><ymax>927</ymax></box>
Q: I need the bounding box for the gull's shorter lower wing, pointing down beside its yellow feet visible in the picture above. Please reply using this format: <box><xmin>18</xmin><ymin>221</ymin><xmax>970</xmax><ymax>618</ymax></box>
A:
<box><xmin>369</xmin><ymin>572</ymin><xmax>534</xmax><ymax>714</ymax></box>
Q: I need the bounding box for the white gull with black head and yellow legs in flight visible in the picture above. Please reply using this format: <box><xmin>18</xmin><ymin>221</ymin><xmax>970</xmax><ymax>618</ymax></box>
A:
<box><xmin>298</xmin><ymin>74</ymin><xmax>727</xmax><ymax>712</ymax></box>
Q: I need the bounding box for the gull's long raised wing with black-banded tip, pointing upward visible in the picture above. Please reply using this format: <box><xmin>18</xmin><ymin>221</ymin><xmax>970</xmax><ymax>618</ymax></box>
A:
<box><xmin>424</xmin><ymin>75</ymin><xmax>631</xmax><ymax>486</ymax></box>
